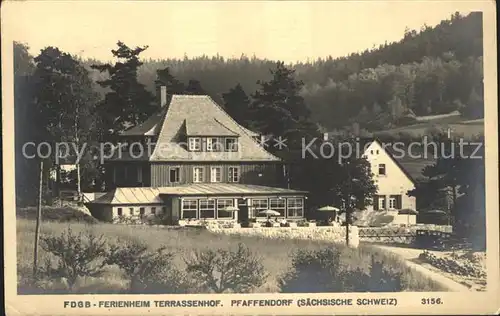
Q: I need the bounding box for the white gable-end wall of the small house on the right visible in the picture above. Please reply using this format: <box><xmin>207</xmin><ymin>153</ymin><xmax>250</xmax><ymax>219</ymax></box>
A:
<box><xmin>364</xmin><ymin>142</ymin><xmax>416</xmax><ymax>210</ymax></box>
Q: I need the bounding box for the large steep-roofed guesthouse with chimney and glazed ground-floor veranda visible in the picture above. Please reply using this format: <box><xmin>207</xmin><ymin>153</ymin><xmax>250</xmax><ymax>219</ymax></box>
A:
<box><xmin>87</xmin><ymin>87</ymin><xmax>306</xmax><ymax>225</ymax></box>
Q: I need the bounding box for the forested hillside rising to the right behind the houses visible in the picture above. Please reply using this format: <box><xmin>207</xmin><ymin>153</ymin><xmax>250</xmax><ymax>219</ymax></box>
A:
<box><xmin>86</xmin><ymin>13</ymin><xmax>483</xmax><ymax>130</ymax></box>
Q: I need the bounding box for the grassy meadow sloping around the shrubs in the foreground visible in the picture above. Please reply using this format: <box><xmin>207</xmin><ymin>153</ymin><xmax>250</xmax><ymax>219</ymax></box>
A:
<box><xmin>17</xmin><ymin>219</ymin><xmax>441</xmax><ymax>294</ymax></box>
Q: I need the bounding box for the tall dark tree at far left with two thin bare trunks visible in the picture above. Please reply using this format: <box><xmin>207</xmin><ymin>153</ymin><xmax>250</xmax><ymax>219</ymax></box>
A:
<box><xmin>34</xmin><ymin>47</ymin><xmax>98</xmax><ymax>200</ymax></box>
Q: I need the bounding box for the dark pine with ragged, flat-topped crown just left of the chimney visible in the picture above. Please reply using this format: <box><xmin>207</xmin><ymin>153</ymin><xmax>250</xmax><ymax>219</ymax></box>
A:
<box><xmin>92</xmin><ymin>42</ymin><xmax>157</xmax><ymax>134</ymax></box>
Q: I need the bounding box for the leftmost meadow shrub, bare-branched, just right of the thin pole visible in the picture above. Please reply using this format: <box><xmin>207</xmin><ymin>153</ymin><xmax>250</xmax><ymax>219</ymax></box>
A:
<box><xmin>40</xmin><ymin>228</ymin><xmax>106</xmax><ymax>290</ymax></box>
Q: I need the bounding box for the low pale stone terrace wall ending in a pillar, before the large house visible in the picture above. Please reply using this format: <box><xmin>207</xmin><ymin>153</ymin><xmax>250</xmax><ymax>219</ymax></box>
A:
<box><xmin>207</xmin><ymin>226</ymin><xmax>359</xmax><ymax>248</ymax></box>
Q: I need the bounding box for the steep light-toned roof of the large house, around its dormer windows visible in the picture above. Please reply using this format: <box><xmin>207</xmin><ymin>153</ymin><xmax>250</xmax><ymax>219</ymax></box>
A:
<box><xmin>150</xmin><ymin>95</ymin><xmax>280</xmax><ymax>161</ymax></box>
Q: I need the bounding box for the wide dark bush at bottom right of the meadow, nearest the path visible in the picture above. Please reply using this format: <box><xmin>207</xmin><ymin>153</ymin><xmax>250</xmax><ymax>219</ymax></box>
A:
<box><xmin>278</xmin><ymin>248</ymin><xmax>404</xmax><ymax>293</ymax></box>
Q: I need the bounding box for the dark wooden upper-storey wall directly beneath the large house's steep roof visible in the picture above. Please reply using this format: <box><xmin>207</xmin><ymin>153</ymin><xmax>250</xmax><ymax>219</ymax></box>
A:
<box><xmin>150</xmin><ymin>162</ymin><xmax>284</xmax><ymax>187</ymax></box>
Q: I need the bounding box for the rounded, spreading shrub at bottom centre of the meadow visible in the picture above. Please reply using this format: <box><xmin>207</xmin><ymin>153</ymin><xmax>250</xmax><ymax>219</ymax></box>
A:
<box><xmin>185</xmin><ymin>243</ymin><xmax>267</xmax><ymax>293</ymax></box>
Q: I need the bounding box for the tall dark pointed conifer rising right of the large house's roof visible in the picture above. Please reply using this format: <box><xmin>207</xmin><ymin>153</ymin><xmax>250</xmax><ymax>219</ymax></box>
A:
<box><xmin>251</xmin><ymin>62</ymin><xmax>317</xmax><ymax>148</ymax></box>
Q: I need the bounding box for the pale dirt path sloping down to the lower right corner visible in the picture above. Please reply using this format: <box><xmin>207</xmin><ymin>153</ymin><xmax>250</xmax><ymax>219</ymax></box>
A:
<box><xmin>373</xmin><ymin>245</ymin><xmax>470</xmax><ymax>292</ymax></box>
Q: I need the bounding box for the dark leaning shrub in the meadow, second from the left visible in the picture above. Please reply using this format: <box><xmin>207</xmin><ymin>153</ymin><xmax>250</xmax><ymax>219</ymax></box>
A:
<box><xmin>105</xmin><ymin>243</ymin><xmax>187</xmax><ymax>294</ymax></box>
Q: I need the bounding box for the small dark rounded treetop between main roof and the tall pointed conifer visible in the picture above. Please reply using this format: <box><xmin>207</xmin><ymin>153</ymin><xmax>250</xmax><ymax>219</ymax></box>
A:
<box><xmin>222</xmin><ymin>83</ymin><xmax>250</xmax><ymax>127</ymax></box>
